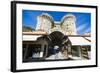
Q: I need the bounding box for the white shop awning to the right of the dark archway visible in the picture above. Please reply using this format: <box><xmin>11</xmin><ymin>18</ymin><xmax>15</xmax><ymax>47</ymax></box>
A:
<box><xmin>69</xmin><ymin>36</ymin><xmax>91</xmax><ymax>45</ymax></box>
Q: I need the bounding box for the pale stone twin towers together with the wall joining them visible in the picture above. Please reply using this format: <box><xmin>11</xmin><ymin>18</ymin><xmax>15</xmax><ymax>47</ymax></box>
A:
<box><xmin>36</xmin><ymin>13</ymin><xmax>77</xmax><ymax>35</ymax></box>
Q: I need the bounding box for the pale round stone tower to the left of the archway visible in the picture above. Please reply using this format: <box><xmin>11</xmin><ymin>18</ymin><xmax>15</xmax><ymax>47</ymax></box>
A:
<box><xmin>36</xmin><ymin>13</ymin><xmax>54</xmax><ymax>32</ymax></box>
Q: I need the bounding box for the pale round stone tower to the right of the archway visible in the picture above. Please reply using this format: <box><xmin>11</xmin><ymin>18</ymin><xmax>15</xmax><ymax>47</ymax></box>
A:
<box><xmin>61</xmin><ymin>14</ymin><xmax>77</xmax><ymax>35</ymax></box>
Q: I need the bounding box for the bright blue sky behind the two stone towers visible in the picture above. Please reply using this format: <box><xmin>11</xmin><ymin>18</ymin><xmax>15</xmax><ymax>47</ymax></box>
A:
<box><xmin>22</xmin><ymin>10</ymin><xmax>91</xmax><ymax>34</ymax></box>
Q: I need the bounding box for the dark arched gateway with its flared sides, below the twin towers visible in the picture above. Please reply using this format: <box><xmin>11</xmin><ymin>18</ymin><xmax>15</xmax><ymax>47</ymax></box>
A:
<box><xmin>37</xmin><ymin>31</ymin><xmax>71</xmax><ymax>59</ymax></box>
